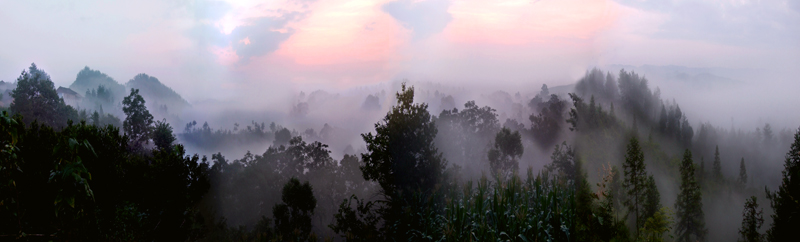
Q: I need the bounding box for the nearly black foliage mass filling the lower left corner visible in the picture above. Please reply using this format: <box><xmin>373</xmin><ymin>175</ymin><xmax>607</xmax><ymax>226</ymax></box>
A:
<box><xmin>0</xmin><ymin>111</ymin><xmax>209</xmax><ymax>241</ymax></box>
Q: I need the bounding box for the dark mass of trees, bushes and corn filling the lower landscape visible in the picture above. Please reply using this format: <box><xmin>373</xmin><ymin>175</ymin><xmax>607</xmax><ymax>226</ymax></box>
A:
<box><xmin>0</xmin><ymin>66</ymin><xmax>800</xmax><ymax>241</ymax></box>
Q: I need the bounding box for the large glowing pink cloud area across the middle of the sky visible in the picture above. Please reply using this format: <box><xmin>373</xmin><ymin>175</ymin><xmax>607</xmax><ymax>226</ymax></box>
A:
<box><xmin>216</xmin><ymin>0</ymin><xmax>619</xmax><ymax>86</ymax></box>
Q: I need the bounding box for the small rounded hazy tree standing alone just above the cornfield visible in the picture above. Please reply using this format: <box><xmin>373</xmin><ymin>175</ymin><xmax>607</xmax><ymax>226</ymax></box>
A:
<box><xmin>489</xmin><ymin>128</ymin><xmax>523</xmax><ymax>177</ymax></box>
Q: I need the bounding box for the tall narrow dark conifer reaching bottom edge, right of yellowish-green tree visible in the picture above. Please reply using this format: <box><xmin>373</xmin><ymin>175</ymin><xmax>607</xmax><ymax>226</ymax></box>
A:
<box><xmin>675</xmin><ymin>149</ymin><xmax>708</xmax><ymax>242</ymax></box>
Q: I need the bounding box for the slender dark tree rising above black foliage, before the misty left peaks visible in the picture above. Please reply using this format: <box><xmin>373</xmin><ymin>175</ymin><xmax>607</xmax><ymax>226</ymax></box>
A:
<box><xmin>122</xmin><ymin>88</ymin><xmax>153</xmax><ymax>150</ymax></box>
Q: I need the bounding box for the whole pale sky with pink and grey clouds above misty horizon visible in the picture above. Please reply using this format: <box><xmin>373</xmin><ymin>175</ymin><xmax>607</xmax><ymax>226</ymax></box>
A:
<box><xmin>0</xmin><ymin>0</ymin><xmax>800</xmax><ymax>102</ymax></box>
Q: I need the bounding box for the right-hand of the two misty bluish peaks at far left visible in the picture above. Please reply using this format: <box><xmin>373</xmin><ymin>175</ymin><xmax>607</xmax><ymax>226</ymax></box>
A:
<box><xmin>125</xmin><ymin>73</ymin><xmax>190</xmax><ymax>113</ymax></box>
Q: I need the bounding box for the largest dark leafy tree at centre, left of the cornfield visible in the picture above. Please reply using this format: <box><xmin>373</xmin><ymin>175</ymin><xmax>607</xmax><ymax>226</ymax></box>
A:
<box><xmin>361</xmin><ymin>83</ymin><xmax>447</xmax><ymax>219</ymax></box>
